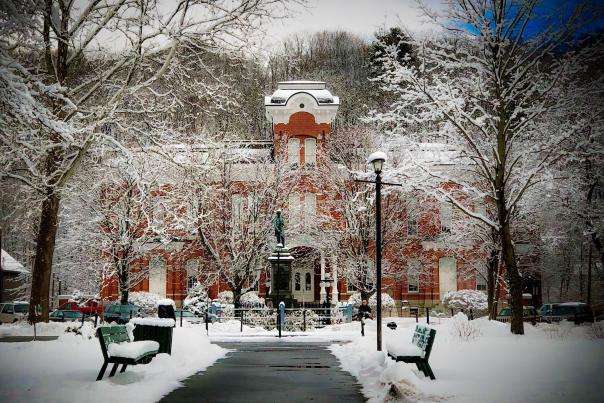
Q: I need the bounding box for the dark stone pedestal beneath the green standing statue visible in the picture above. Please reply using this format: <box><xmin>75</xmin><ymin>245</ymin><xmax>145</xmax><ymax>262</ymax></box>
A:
<box><xmin>268</xmin><ymin>244</ymin><xmax>296</xmax><ymax>308</ymax></box>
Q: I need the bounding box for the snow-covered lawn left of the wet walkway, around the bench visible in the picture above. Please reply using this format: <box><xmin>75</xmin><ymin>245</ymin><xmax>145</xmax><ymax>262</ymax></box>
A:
<box><xmin>0</xmin><ymin>323</ymin><xmax>227</xmax><ymax>403</ymax></box>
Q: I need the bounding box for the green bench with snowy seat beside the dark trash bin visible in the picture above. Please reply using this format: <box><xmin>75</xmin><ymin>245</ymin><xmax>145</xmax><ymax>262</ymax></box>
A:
<box><xmin>96</xmin><ymin>326</ymin><xmax>159</xmax><ymax>381</ymax></box>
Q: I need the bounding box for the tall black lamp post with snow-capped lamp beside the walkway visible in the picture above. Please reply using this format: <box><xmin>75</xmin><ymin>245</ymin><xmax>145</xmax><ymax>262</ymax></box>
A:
<box><xmin>368</xmin><ymin>151</ymin><xmax>386</xmax><ymax>351</ymax></box>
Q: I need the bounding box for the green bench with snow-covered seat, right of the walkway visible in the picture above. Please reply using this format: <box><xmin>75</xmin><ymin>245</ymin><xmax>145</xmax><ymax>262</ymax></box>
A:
<box><xmin>386</xmin><ymin>325</ymin><xmax>436</xmax><ymax>379</ymax></box>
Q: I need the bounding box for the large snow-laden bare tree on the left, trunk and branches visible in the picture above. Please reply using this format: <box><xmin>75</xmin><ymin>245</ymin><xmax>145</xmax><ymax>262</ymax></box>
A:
<box><xmin>0</xmin><ymin>0</ymin><xmax>298</xmax><ymax>322</ymax></box>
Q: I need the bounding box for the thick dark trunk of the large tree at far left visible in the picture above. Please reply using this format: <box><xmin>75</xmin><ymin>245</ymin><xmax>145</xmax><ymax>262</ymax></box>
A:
<box><xmin>29</xmin><ymin>187</ymin><xmax>60</xmax><ymax>323</ymax></box>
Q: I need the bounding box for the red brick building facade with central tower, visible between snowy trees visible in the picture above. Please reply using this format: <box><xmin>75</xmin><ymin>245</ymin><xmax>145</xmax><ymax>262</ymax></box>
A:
<box><xmin>102</xmin><ymin>81</ymin><xmax>498</xmax><ymax>306</ymax></box>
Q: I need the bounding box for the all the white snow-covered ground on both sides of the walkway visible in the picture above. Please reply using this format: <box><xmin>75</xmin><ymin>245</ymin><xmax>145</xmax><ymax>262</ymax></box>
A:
<box><xmin>0</xmin><ymin>318</ymin><xmax>604</xmax><ymax>403</ymax></box>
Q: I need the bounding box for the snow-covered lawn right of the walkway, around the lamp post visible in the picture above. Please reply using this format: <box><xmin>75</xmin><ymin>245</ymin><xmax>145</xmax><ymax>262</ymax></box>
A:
<box><xmin>331</xmin><ymin>317</ymin><xmax>604</xmax><ymax>402</ymax></box>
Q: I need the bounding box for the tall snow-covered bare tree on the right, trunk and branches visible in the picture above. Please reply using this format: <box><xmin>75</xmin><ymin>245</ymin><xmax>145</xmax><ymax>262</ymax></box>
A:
<box><xmin>372</xmin><ymin>0</ymin><xmax>602</xmax><ymax>334</ymax></box>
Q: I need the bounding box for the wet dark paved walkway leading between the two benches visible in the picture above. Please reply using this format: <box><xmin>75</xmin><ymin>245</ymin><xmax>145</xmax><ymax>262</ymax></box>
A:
<box><xmin>161</xmin><ymin>341</ymin><xmax>365</xmax><ymax>403</ymax></box>
